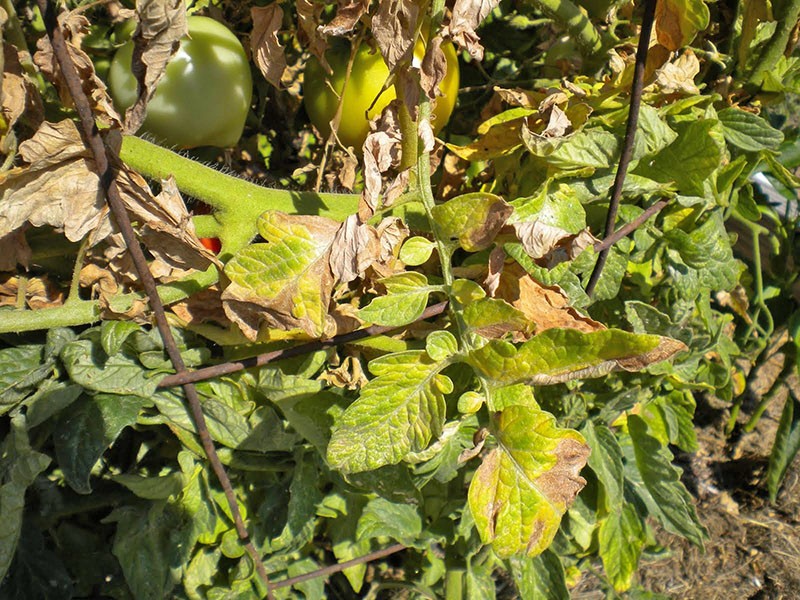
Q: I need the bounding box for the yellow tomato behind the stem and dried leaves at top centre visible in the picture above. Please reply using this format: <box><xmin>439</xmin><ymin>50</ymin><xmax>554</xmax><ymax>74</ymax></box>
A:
<box><xmin>303</xmin><ymin>40</ymin><xmax>458</xmax><ymax>150</ymax></box>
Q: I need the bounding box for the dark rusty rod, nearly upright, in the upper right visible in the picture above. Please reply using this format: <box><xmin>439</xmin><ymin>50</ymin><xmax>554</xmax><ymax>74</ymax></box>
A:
<box><xmin>586</xmin><ymin>0</ymin><xmax>656</xmax><ymax>296</ymax></box>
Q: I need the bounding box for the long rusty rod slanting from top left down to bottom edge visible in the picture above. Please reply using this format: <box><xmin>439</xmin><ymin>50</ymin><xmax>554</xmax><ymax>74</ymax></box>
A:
<box><xmin>37</xmin><ymin>0</ymin><xmax>273</xmax><ymax>600</ymax></box>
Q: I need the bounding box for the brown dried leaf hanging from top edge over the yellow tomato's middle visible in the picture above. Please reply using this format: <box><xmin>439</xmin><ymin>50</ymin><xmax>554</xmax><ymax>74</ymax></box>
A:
<box><xmin>372</xmin><ymin>0</ymin><xmax>416</xmax><ymax>73</ymax></box>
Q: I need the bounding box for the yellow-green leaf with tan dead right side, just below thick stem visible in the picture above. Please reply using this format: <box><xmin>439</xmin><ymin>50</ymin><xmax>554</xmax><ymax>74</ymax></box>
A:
<box><xmin>222</xmin><ymin>211</ymin><xmax>339</xmax><ymax>337</ymax></box>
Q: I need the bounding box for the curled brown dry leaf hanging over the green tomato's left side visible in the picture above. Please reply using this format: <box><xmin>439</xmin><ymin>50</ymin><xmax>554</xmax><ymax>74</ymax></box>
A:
<box><xmin>125</xmin><ymin>0</ymin><xmax>189</xmax><ymax>132</ymax></box>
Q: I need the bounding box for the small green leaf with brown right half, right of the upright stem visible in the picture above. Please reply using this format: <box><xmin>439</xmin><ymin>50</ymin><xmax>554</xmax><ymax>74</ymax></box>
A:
<box><xmin>432</xmin><ymin>192</ymin><xmax>514</xmax><ymax>252</ymax></box>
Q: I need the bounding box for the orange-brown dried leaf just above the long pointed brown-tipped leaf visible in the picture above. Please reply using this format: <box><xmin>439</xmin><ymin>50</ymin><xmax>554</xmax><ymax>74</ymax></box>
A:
<box><xmin>492</xmin><ymin>262</ymin><xmax>605</xmax><ymax>333</ymax></box>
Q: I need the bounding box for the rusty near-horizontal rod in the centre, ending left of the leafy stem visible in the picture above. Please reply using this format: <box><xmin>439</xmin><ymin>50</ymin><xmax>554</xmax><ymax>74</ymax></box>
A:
<box><xmin>158</xmin><ymin>302</ymin><xmax>447</xmax><ymax>388</ymax></box>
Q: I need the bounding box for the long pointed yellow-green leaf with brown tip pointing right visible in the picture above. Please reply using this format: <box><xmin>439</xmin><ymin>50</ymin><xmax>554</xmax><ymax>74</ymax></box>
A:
<box><xmin>467</xmin><ymin>329</ymin><xmax>684</xmax><ymax>385</ymax></box>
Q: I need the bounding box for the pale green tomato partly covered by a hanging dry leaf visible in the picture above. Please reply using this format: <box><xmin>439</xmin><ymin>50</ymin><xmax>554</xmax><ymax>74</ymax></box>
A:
<box><xmin>108</xmin><ymin>16</ymin><xmax>253</xmax><ymax>148</ymax></box>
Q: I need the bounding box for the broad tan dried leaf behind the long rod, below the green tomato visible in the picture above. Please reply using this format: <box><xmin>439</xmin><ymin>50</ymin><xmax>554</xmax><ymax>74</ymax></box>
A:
<box><xmin>0</xmin><ymin>120</ymin><xmax>216</xmax><ymax>282</ymax></box>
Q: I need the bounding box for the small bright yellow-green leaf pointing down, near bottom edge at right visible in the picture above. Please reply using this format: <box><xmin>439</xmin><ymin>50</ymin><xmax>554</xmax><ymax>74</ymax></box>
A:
<box><xmin>598</xmin><ymin>501</ymin><xmax>645</xmax><ymax>592</ymax></box>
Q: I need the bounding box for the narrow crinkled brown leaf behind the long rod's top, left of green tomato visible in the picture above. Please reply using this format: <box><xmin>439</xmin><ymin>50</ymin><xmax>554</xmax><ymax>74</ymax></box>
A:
<box><xmin>33</xmin><ymin>12</ymin><xmax>121</xmax><ymax>127</ymax></box>
